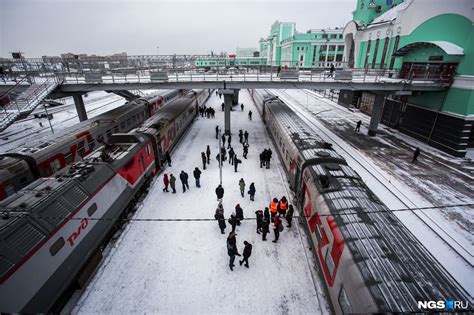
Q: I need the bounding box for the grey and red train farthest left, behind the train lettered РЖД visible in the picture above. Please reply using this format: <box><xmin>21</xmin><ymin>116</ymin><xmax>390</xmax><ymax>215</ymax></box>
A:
<box><xmin>0</xmin><ymin>90</ymin><xmax>186</xmax><ymax>200</ymax></box>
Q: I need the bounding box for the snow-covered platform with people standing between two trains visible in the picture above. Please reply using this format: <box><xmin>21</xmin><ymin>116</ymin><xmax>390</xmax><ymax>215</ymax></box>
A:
<box><xmin>73</xmin><ymin>91</ymin><xmax>329</xmax><ymax>314</ymax></box>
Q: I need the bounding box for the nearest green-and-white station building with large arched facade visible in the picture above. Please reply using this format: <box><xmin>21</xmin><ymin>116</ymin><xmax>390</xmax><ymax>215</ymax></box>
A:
<box><xmin>339</xmin><ymin>0</ymin><xmax>474</xmax><ymax>156</ymax></box>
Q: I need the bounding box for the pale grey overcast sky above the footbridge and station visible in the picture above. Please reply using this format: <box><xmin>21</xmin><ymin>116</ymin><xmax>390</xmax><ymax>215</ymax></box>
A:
<box><xmin>0</xmin><ymin>0</ymin><xmax>356</xmax><ymax>57</ymax></box>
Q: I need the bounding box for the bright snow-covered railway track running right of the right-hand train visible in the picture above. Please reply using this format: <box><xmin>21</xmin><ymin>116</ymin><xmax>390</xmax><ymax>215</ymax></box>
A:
<box><xmin>272</xmin><ymin>90</ymin><xmax>473</xmax><ymax>267</ymax></box>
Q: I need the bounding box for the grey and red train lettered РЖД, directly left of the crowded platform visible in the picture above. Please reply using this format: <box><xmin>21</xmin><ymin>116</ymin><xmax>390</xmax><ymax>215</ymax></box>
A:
<box><xmin>0</xmin><ymin>90</ymin><xmax>210</xmax><ymax>313</ymax></box>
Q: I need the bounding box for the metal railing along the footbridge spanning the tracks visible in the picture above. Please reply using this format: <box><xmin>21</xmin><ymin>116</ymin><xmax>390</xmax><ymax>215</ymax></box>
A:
<box><xmin>0</xmin><ymin>55</ymin><xmax>452</xmax><ymax>84</ymax></box>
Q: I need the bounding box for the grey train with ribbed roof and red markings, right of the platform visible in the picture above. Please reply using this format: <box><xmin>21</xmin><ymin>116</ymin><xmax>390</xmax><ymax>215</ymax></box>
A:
<box><xmin>251</xmin><ymin>90</ymin><xmax>472</xmax><ymax>314</ymax></box>
